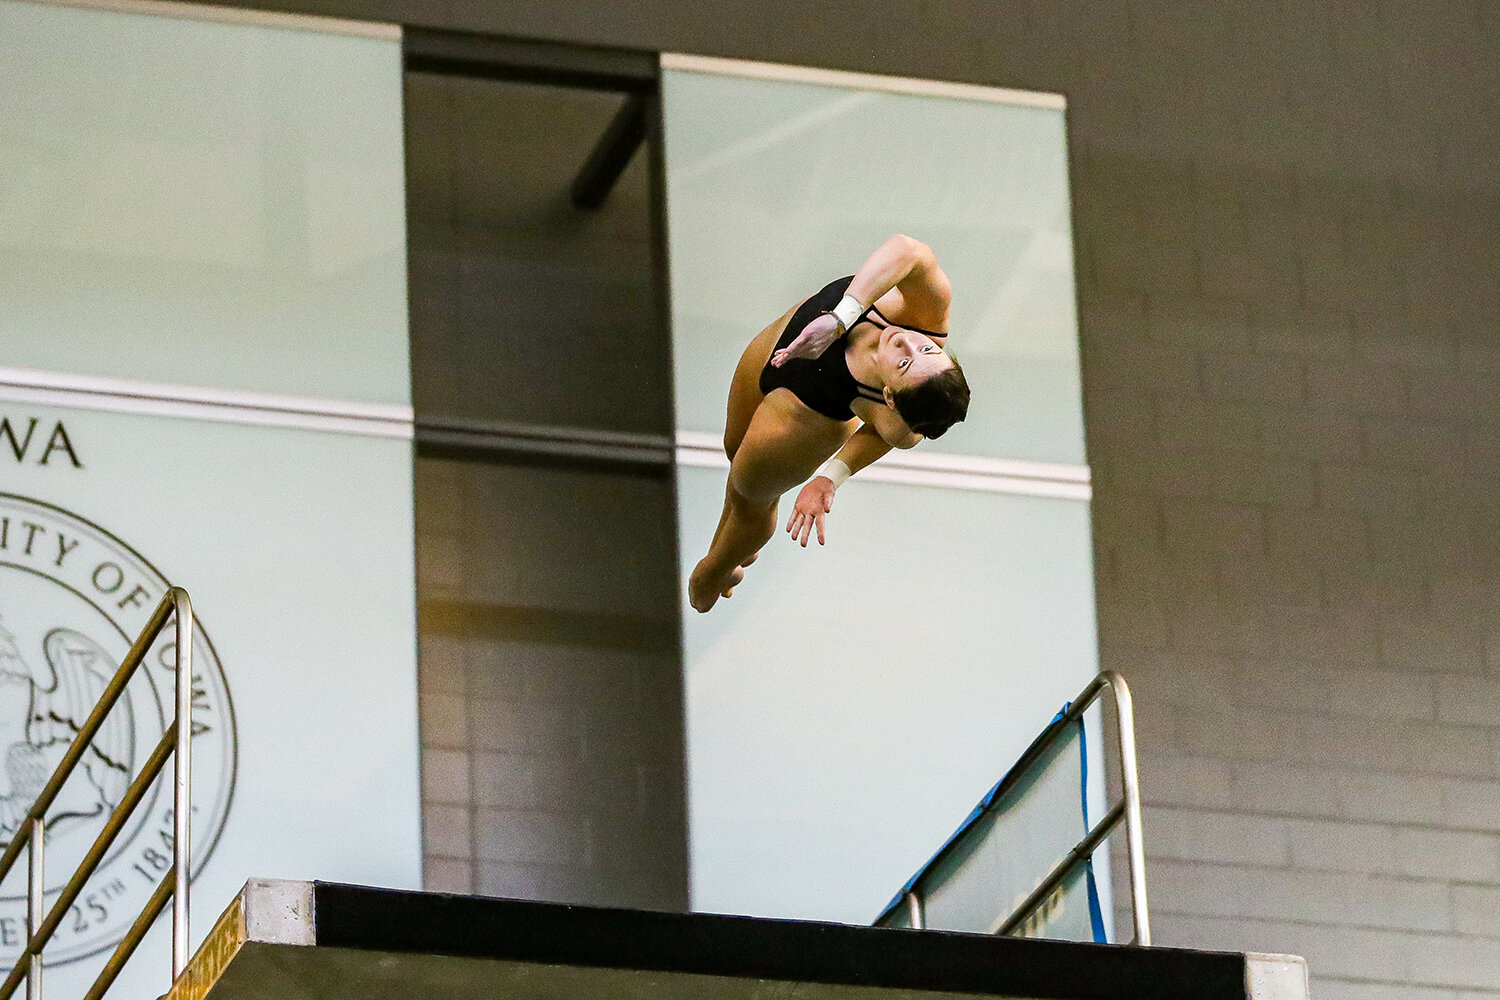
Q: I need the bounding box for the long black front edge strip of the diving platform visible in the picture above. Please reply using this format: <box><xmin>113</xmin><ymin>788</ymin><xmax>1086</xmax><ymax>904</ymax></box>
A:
<box><xmin>314</xmin><ymin>882</ymin><xmax>1248</xmax><ymax>1000</ymax></box>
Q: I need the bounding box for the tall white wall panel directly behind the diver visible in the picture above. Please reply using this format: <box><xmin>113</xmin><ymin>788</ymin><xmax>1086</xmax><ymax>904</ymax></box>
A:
<box><xmin>665</xmin><ymin>67</ymin><xmax>1097</xmax><ymax>924</ymax></box>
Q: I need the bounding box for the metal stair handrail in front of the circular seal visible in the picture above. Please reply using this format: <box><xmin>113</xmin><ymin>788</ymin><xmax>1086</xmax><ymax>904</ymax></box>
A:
<box><xmin>0</xmin><ymin>586</ymin><xmax>194</xmax><ymax>1000</ymax></box>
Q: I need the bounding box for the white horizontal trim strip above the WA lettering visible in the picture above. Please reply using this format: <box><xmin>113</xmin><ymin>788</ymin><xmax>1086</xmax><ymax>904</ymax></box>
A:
<box><xmin>0</xmin><ymin>367</ymin><xmax>413</xmax><ymax>439</ymax></box>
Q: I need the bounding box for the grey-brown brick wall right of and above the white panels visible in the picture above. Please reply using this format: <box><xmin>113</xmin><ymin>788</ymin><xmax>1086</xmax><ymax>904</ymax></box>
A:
<box><xmin>199</xmin><ymin>0</ymin><xmax>1500</xmax><ymax>1000</ymax></box>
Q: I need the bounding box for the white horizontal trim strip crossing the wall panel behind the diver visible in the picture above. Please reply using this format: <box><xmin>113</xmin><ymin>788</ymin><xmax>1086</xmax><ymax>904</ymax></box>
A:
<box><xmin>677</xmin><ymin>430</ymin><xmax>1094</xmax><ymax>501</ymax></box>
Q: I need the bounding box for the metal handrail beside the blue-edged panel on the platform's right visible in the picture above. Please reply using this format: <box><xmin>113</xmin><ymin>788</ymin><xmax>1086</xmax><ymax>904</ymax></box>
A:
<box><xmin>894</xmin><ymin>670</ymin><xmax>1151</xmax><ymax>947</ymax></box>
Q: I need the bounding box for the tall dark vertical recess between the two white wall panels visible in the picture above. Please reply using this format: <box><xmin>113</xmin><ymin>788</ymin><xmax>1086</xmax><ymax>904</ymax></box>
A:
<box><xmin>404</xmin><ymin>30</ymin><xmax>687</xmax><ymax>910</ymax></box>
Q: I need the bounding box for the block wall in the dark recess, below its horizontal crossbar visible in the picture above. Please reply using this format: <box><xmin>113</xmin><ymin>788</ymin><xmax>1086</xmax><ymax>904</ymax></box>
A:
<box><xmin>417</xmin><ymin>459</ymin><xmax>687</xmax><ymax>910</ymax></box>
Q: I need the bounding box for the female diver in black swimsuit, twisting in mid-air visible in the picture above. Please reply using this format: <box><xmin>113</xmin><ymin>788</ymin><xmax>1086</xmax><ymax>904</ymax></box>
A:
<box><xmin>687</xmin><ymin>235</ymin><xmax>969</xmax><ymax>612</ymax></box>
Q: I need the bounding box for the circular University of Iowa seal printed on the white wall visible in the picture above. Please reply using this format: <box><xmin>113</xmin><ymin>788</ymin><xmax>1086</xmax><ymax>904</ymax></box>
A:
<box><xmin>0</xmin><ymin>493</ymin><xmax>236</xmax><ymax>966</ymax></box>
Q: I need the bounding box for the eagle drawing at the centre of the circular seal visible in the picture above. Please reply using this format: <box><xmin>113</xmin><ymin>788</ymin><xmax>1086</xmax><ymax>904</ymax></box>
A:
<box><xmin>0</xmin><ymin>624</ymin><xmax>135</xmax><ymax>841</ymax></box>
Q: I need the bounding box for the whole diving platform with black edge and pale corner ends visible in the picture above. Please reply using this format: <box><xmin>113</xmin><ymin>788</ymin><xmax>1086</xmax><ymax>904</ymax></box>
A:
<box><xmin>167</xmin><ymin>879</ymin><xmax>1307</xmax><ymax>1000</ymax></box>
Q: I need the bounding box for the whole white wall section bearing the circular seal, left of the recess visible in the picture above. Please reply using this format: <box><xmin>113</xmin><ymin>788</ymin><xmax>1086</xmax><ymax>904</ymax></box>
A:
<box><xmin>0</xmin><ymin>1</ymin><xmax>420</xmax><ymax>996</ymax></box>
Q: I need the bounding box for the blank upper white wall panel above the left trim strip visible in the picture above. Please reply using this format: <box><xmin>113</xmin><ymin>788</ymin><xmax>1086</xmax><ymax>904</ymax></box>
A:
<box><xmin>0</xmin><ymin>0</ymin><xmax>411</xmax><ymax>405</ymax></box>
